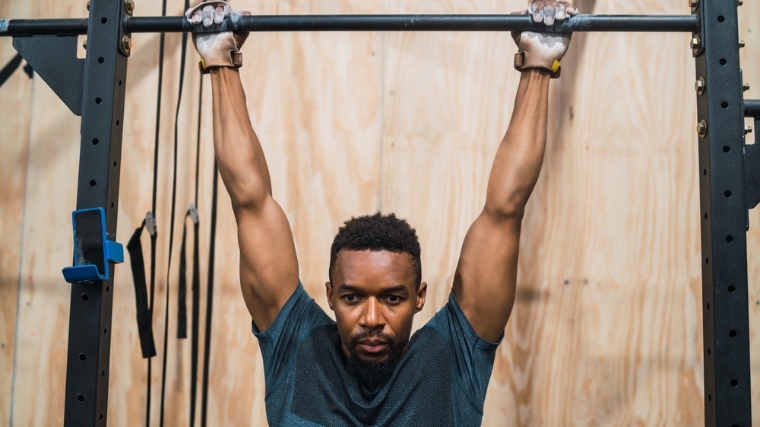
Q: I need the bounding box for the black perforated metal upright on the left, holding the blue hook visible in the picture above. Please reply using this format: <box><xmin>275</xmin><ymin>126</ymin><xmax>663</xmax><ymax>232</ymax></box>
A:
<box><xmin>64</xmin><ymin>0</ymin><xmax>127</xmax><ymax>427</ymax></box>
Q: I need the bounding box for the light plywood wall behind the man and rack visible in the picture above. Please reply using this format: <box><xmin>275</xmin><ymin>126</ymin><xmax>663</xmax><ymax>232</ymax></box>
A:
<box><xmin>0</xmin><ymin>0</ymin><xmax>760</xmax><ymax>426</ymax></box>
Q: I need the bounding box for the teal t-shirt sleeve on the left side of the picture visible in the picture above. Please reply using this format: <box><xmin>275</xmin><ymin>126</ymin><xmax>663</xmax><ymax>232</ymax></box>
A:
<box><xmin>251</xmin><ymin>282</ymin><xmax>333</xmax><ymax>390</ymax></box>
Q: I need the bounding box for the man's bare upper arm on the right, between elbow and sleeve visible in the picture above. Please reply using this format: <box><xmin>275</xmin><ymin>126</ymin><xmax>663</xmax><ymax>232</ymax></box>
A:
<box><xmin>454</xmin><ymin>212</ymin><xmax>520</xmax><ymax>341</ymax></box>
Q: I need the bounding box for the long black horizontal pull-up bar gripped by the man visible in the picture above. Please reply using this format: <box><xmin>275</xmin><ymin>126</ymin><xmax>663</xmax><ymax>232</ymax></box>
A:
<box><xmin>0</xmin><ymin>15</ymin><xmax>699</xmax><ymax>36</ymax></box>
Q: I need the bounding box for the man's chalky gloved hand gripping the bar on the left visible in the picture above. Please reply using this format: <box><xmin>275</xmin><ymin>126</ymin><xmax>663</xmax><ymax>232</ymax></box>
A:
<box><xmin>185</xmin><ymin>1</ymin><xmax>251</xmax><ymax>68</ymax></box>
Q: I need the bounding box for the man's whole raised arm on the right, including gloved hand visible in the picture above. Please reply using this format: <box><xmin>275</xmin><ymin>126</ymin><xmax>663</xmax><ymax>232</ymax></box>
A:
<box><xmin>454</xmin><ymin>0</ymin><xmax>577</xmax><ymax>341</ymax></box>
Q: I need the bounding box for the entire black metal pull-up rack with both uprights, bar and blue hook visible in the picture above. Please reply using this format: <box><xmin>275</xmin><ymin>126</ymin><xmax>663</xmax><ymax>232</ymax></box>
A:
<box><xmin>0</xmin><ymin>0</ymin><xmax>760</xmax><ymax>427</ymax></box>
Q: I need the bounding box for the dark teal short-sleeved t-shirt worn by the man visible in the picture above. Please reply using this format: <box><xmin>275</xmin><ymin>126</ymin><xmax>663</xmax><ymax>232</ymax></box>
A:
<box><xmin>253</xmin><ymin>283</ymin><xmax>499</xmax><ymax>427</ymax></box>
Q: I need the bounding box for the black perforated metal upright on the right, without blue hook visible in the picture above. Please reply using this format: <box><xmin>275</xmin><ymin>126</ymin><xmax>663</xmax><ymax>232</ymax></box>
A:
<box><xmin>692</xmin><ymin>0</ymin><xmax>752</xmax><ymax>427</ymax></box>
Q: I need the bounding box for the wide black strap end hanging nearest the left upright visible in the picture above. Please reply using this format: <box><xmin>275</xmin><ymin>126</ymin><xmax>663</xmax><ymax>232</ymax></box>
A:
<box><xmin>127</xmin><ymin>221</ymin><xmax>156</xmax><ymax>359</ymax></box>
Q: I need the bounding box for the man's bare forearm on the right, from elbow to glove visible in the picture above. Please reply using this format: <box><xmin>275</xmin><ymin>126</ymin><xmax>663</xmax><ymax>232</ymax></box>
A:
<box><xmin>485</xmin><ymin>69</ymin><xmax>550</xmax><ymax>217</ymax></box>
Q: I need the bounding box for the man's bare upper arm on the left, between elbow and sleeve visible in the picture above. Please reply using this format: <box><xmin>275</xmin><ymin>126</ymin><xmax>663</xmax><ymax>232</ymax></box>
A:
<box><xmin>235</xmin><ymin>196</ymin><xmax>298</xmax><ymax>331</ymax></box>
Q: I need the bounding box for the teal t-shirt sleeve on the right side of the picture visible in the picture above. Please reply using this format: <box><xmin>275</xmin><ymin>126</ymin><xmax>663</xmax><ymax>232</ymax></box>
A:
<box><xmin>426</xmin><ymin>292</ymin><xmax>504</xmax><ymax>411</ymax></box>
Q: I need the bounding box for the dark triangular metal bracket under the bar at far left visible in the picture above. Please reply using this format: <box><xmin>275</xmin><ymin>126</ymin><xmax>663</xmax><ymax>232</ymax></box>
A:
<box><xmin>13</xmin><ymin>35</ymin><xmax>84</xmax><ymax>116</ymax></box>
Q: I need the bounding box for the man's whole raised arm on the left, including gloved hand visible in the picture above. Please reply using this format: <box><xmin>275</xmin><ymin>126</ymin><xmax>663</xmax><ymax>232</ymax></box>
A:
<box><xmin>186</xmin><ymin>2</ymin><xmax>298</xmax><ymax>331</ymax></box>
